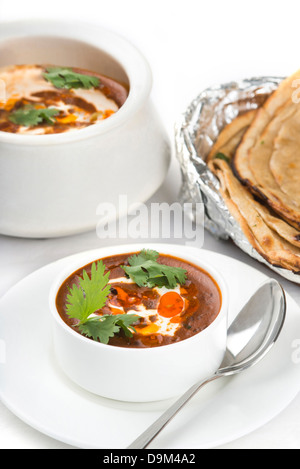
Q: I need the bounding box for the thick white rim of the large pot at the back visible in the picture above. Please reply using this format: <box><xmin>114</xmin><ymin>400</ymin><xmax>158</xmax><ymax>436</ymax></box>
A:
<box><xmin>0</xmin><ymin>19</ymin><xmax>153</xmax><ymax>146</ymax></box>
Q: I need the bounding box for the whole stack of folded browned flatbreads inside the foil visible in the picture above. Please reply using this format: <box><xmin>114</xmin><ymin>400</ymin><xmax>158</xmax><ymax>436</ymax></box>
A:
<box><xmin>207</xmin><ymin>71</ymin><xmax>300</xmax><ymax>273</ymax></box>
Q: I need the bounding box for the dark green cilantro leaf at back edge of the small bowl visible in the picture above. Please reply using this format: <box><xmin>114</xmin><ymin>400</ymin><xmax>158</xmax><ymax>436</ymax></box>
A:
<box><xmin>122</xmin><ymin>250</ymin><xmax>187</xmax><ymax>289</ymax></box>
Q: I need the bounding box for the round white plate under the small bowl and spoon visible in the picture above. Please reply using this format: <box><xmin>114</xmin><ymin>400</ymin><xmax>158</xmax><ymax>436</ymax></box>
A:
<box><xmin>0</xmin><ymin>245</ymin><xmax>300</xmax><ymax>449</ymax></box>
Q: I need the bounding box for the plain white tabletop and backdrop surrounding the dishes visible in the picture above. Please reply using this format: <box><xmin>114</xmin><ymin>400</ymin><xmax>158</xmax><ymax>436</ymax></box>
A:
<box><xmin>0</xmin><ymin>0</ymin><xmax>300</xmax><ymax>449</ymax></box>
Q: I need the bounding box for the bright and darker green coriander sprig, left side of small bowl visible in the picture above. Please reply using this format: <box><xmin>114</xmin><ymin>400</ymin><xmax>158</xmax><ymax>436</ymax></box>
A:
<box><xmin>66</xmin><ymin>261</ymin><xmax>140</xmax><ymax>344</ymax></box>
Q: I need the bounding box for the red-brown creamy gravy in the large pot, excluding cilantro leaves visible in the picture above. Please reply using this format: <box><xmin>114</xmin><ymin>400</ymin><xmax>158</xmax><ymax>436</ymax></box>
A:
<box><xmin>0</xmin><ymin>65</ymin><xmax>129</xmax><ymax>135</ymax></box>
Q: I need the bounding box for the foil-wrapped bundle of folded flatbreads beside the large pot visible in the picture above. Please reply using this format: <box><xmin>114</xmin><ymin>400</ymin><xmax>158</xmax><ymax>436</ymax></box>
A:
<box><xmin>175</xmin><ymin>72</ymin><xmax>300</xmax><ymax>283</ymax></box>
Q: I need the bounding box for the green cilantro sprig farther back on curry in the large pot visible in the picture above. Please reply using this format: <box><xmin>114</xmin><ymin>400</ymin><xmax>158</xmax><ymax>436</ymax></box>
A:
<box><xmin>43</xmin><ymin>67</ymin><xmax>100</xmax><ymax>90</ymax></box>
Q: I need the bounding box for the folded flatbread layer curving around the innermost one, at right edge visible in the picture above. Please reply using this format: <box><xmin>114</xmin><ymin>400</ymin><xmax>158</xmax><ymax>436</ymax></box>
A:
<box><xmin>233</xmin><ymin>71</ymin><xmax>300</xmax><ymax>228</ymax></box>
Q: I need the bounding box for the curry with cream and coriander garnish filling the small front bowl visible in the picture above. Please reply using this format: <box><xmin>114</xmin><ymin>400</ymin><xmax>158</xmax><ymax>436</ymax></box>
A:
<box><xmin>56</xmin><ymin>249</ymin><xmax>222</xmax><ymax>348</ymax></box>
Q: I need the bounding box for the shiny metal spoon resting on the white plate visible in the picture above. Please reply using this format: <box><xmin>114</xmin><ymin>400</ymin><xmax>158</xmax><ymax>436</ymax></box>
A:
<box><xmin>128</xmin><ymin>279</ymin><xmax>286</xmax><ymax>449</ymax></box>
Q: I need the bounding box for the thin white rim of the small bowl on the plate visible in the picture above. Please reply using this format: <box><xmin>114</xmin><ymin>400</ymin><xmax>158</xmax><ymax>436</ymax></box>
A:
<box><xmin>49</xmin><ymin>243</ymin><xmax>229</xmax><ymax>354</ymax></box>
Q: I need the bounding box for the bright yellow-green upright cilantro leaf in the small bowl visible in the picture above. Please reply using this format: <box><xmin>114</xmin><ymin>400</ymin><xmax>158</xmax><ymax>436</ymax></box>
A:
<box><xmin>66</xmin><ymin>261</ymin><xmax>110</xmax><ymax>322</ymax></box>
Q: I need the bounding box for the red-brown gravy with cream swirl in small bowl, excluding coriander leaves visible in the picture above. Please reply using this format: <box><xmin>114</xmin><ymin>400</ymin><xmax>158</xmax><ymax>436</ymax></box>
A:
<box><xmin>56</xmin><ymin>254</ymin><xmax>222</xmax><ymax>348</ymax></box>
